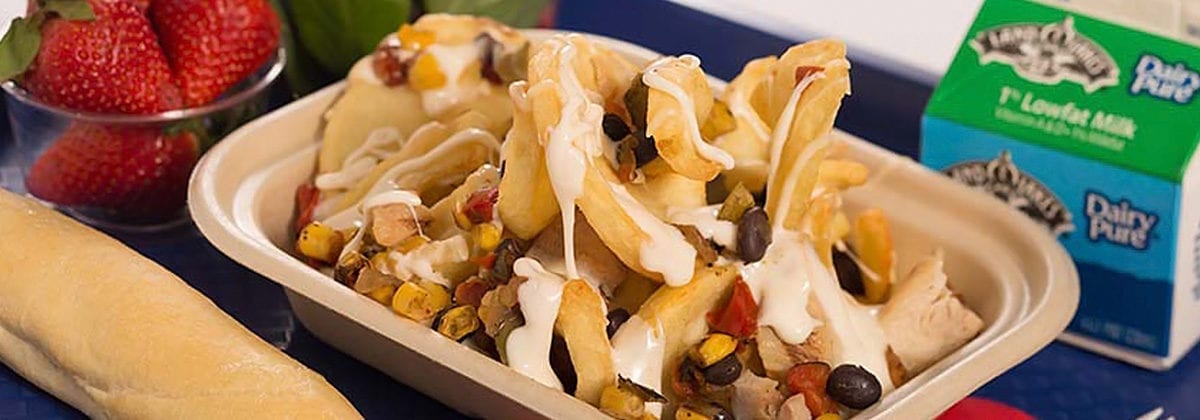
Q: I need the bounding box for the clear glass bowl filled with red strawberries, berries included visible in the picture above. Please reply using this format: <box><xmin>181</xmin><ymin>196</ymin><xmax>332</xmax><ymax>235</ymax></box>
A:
<box><xmin>0</xmin><ymin>0</ymin><xmax>286</xmax><ymax>230</ymax></box>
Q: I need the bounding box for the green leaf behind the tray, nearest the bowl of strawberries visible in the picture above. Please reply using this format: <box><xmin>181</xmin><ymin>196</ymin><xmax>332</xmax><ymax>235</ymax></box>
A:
<box><xmin>288</xmin><ymin>0</ymin><xmax>412</xmax><ymax>74</ymax></box>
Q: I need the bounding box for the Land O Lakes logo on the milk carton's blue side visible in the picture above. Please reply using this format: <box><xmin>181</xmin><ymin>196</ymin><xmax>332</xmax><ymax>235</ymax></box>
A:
<box><xmin>944</xmin><ymin>150</ymin><xmax>1075</xmax><ymax>236</ymax></box>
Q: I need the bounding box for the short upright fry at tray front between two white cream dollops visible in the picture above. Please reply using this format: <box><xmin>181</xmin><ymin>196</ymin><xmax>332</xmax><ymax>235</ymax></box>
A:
<box><xmin>554</xmin><ymin>280</ymin><xmax>617</xmax><ymax>406</ymax></box>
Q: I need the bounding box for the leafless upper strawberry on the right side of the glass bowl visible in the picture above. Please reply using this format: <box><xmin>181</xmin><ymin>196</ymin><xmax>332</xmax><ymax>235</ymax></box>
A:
<box><xmin>150</xmin><ymin>0</ymin><xmax>280</xmax><ymax>107</ymax></box>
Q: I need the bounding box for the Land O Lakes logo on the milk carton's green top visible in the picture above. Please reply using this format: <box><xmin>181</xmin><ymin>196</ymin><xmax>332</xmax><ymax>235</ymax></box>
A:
<box><xmin>970</xmin><ymin>16</ymin><xmax>1121</xmax><ymax>94</ymax></box>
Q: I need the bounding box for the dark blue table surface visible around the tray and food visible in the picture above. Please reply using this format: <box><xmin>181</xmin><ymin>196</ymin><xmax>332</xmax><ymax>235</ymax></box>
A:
<box><xmin>0</xmin><ymin>0</ymin><xmax>1200</xmax><ymax>419</ymax></box>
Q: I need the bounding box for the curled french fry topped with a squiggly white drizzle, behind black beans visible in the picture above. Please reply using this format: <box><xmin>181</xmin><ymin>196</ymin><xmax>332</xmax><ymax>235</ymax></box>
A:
<box><xmin>642</xmin><ymin>56</ymin><xmax>734</xmax><ymax>181</ymax></box>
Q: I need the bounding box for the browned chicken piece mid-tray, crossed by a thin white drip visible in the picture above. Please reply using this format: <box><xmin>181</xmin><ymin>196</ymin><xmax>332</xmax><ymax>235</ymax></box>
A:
<box><xmin>526</xmin><ymin>212</ymin><xmax>629</xmax><ymax>296</ymax></box>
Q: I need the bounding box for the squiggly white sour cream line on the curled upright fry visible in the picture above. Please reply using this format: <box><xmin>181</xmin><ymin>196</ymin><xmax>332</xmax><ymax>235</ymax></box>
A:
<box><xmin>642</xmin><ymin>54</ymin><xmax>734</xmax><ymax>169</ymax></box>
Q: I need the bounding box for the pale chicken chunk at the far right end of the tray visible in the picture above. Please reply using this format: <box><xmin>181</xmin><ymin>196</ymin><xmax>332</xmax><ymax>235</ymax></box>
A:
<box><xmin>880</xmin><ymin>252</ymin><xmax>983</xmax><ymax>374</ymax></box>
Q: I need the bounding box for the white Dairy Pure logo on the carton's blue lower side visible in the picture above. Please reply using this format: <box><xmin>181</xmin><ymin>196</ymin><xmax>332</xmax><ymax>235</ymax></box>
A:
<box><xmin>1084</xmin><ymin>191</ymin><xmax>1158</xmax><ymax>250</ymax></box>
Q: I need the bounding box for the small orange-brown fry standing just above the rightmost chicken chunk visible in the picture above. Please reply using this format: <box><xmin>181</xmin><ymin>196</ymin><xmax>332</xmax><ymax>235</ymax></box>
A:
<box><xmin>851</xmin><ymin>209</ymin><xmax>895</xmax><ymax>304</ymax></box>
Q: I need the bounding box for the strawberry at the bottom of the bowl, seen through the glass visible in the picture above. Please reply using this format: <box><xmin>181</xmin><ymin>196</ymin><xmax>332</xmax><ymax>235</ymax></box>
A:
<box><xmin>25</xmin><ymin>122</ymin><xmax>198</xmax><ymax>220</ymax></box>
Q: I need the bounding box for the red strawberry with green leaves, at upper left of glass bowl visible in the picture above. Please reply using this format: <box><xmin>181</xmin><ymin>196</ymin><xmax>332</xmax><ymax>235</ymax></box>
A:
<box><xmin>0</xmin><ymin>0</ymin><xmax>182</xmax><ymax>114</ymax></box>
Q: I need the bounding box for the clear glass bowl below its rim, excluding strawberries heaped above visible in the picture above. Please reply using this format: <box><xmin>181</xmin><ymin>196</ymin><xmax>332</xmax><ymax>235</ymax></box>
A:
<box><xmin>0</xmin><ymin>48</ymin><xmax>287</xmax><ymax>232</ymax></box>
